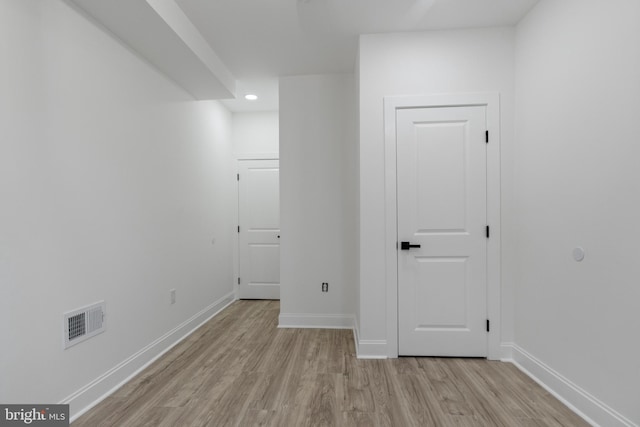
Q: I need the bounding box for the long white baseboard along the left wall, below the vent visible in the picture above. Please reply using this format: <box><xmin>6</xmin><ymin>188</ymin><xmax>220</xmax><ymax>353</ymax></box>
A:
<box><xmin>60</xmin><ymin>292</ymin><xmax>235</xmax><ymax>422</ymax></box>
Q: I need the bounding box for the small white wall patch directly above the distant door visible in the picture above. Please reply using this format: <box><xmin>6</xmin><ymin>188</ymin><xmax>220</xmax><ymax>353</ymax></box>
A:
<box><xmin>232</xmin><ymin>111</ymin><xmax>280</xmax><ymax>158</ymax></box>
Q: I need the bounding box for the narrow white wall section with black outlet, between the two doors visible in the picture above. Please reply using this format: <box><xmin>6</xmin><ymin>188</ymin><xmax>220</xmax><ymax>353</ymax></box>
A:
<box><xmin>280</xmin><ymin>74</ymin><xmax>358</xmax><ymax>326</ymax></box>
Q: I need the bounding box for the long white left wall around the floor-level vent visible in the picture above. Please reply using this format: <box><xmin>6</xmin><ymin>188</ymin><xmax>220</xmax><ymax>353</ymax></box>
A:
<box><xmin>0</xmin><ymin>0</ymin><xmax>235</xmax><ymax>413</ymax></box>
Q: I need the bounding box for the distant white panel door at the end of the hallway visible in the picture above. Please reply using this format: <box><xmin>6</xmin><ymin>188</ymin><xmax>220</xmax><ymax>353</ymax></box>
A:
<box><xmin>238</xmin><ymin>160</ymin><xmax>280</xmax><ymax>299</ymax></box>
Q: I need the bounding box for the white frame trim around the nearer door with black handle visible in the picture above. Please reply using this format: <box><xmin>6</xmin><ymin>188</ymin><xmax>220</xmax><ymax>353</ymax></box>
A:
<box><xmin>384</xmin><ymin>93</ymin><xmax>501</xmax><ymax>360</ymax></box>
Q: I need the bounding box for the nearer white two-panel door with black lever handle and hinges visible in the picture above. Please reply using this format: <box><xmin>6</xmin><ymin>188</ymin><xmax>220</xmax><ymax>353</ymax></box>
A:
<box><xmin>396</xmin><ymin>106</ymin><xmax>487</xmax><ymax>357</ymax></box>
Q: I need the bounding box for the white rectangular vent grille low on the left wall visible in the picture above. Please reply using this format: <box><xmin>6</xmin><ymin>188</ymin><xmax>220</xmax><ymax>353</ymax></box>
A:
<box><xmin>64</xmin><ymin>301</ymin><xmax>106</xmax><ymax>348</ymax></box>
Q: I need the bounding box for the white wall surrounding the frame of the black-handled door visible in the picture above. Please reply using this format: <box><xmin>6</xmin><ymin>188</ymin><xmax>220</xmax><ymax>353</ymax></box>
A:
<box><xmin>359</xmin><ymin>28</ymin><xmax>515</xmax><ymax>354</ymax></box>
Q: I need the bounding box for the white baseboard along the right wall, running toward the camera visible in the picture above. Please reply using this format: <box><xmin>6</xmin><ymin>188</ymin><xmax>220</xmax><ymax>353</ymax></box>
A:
<box><xmin>502</xmin><ymin>343</ymin><xmax>639</xmax><ymax>427</ymax></box>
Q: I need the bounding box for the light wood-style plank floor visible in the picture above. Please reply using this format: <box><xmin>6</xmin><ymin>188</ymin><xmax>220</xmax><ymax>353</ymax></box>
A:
<box><xmin>73</xmin><ymin>301</ymin><xmax>588</xmax><ymax>427</ymax></box>
